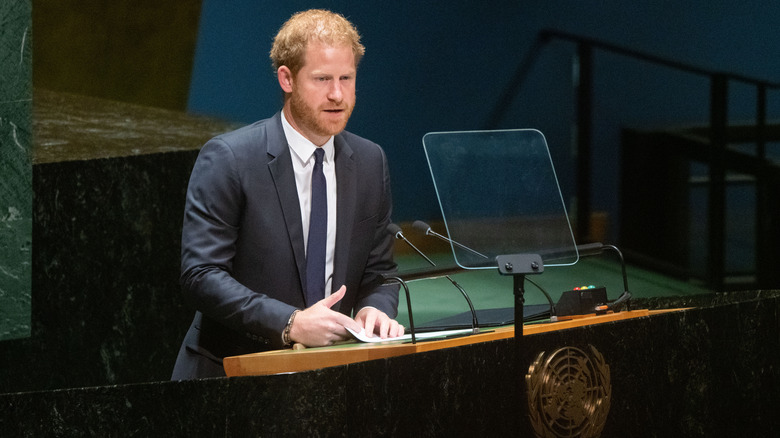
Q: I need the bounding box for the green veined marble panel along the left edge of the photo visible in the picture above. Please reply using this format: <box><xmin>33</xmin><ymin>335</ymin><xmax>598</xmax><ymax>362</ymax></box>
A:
<box><xmin>0</xmin><ymin>1</ymin><xmax>32</xmax><ymax>341</ymax></box>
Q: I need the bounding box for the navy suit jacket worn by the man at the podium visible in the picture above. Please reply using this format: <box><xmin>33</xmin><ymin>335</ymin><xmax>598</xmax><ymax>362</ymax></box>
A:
<box><xmin>172</xmin><ymin>113</ymin><xmax>398</xmax><ymax>380</ymax></box>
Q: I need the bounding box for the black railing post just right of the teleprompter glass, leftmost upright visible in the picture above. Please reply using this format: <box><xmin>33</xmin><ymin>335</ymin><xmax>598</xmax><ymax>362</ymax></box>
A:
<box><xmin>576</xmin><ymin>43</ymin><xmax>593</xmax><ymax>241</ymax></box>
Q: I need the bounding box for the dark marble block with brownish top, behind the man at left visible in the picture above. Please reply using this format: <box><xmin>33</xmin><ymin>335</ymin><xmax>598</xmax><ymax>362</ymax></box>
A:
<box><xmin>0</xmin><ymin>90</ymin><xmax>233</xmax><ymax>392</ymax></box>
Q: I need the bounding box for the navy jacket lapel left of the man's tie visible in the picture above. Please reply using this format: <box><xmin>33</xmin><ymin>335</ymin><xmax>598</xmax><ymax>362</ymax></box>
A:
<box><xmin>267</xmin><ymin>113</ymin><xmax>306</xmax><ymax>299</ymax></box>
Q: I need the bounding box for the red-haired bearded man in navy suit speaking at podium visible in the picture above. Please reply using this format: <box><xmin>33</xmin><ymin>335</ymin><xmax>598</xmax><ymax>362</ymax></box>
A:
<box><xmin>172</xmin><ymin>10</ymin><xmax>404</xmax><ymax>380</ymax></box>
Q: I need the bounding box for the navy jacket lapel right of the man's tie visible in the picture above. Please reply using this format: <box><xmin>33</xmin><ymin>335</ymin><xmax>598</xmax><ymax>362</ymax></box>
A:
<box><xmin>333</xmin><ymin>135</ymin><xmax>357</xmax><ymax>310</ymax></box>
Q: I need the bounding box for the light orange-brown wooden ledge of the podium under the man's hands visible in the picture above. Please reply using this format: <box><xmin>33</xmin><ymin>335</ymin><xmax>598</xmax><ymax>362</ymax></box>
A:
<box><xmin>223</xmin><ymin>309</ymin><xmax>678</xmax><ymax>376</ymax></box>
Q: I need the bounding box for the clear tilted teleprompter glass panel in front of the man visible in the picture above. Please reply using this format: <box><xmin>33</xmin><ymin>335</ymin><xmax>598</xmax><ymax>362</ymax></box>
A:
<box><xmin>423</xmin><ymin>129</ymin><xmax>579</xmax><ymax>269</ymax></box>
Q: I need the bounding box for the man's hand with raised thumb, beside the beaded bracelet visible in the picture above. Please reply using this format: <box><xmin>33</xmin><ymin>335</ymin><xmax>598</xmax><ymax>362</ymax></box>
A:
<box><xmin>290</xmin><ymin>286</ymin><xmax>360</xmax><ymax>347</ymax></box>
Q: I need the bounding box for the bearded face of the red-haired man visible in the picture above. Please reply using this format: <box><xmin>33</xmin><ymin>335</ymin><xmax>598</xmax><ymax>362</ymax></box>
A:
<box><xmin>285</xmin><ymin>42</ymin><xmax>357</xmax><ymax>146</ymax></box>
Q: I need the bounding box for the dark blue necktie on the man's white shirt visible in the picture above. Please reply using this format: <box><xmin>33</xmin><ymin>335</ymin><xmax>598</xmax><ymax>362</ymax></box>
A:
<box><xmin>306</xmin><ymin>148</ymin><xmax>328</xmax><ymax>307</ymax></box>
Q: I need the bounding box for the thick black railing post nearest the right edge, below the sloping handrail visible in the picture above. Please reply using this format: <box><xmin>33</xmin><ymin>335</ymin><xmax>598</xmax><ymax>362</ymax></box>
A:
<box><xmin>707</xmin><ymin>73</ymin><xmax>728</xmax><ymax>291</ymax></box>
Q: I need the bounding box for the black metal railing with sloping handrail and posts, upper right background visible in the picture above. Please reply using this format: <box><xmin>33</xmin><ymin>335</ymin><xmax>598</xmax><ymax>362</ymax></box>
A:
<box><xmin>486</xmin><ymin>29</ymin><xmax>780</xmax><ymax>290</ymax></box>
